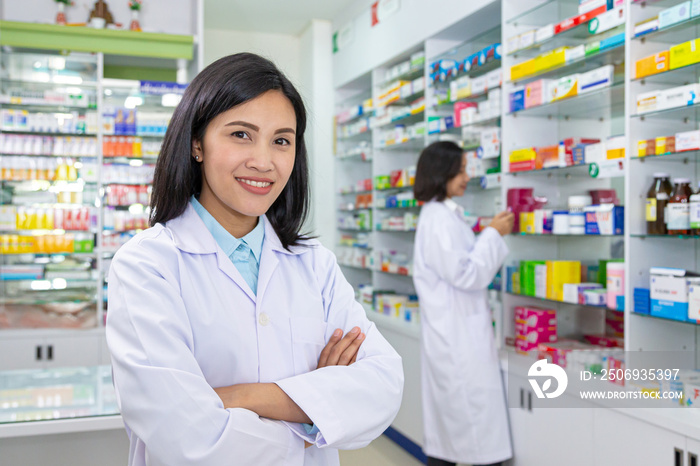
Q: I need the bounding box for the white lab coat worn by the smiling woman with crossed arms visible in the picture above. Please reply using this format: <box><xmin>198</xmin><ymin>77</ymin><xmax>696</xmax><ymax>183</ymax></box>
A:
<box><xmin>107</xmin><ymin>206</ymin><xmax>403</xmax><ymax>466</ymax></box>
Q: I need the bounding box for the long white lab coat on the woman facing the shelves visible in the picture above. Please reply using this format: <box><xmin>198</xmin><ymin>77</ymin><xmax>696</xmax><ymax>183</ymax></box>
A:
<box><xmin>413</xmin><ymin>200</ymin><xmax>512</xmax><ymax>464</ymax></box>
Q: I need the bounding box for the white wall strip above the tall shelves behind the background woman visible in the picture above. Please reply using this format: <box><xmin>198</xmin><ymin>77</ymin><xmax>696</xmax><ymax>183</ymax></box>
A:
<box><xmin>333</xmin><ymin>0</ymin><xmax>496</xmax><ymax>87</ymax></box>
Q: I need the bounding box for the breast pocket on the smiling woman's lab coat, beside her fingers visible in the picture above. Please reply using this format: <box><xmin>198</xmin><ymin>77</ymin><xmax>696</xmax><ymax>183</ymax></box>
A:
<box><xmin>289</xmin><ymin>317</ymin><xmax>328</xmax><ymax>374</ymax></box>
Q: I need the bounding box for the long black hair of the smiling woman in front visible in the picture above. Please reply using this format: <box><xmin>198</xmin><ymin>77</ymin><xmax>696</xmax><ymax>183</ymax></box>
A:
<box><xmin>150</xmin><ymin>53</ymin><xmax>309</xmax><ymax>248</ymax></box>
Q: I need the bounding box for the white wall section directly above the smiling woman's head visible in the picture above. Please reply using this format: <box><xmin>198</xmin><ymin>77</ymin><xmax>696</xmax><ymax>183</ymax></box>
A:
<box><xmin>204</xmin><ymin>28</ymin><xmax>300</xmax><ymax>85</ymax></box>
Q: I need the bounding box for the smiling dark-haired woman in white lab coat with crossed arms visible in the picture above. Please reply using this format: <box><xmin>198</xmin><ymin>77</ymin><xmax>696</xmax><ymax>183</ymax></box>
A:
<box><xmin>107</xmin><ymin>54</ymin><xmax>403</xmax><ymax>466</ymax></box>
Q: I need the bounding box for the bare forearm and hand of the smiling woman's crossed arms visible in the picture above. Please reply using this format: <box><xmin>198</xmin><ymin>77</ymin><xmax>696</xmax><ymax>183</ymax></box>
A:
<box><xmin>214</xmin><ymin>327</ymin><xmax>365</xmax><ymax>424</ymax></box>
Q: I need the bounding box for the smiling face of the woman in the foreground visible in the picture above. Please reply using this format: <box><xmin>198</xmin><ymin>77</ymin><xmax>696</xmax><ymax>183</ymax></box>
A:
<box><xmin>192</xmin><ymin>90</ymin><xmax>297</xmax><ymax>231</ymax></box>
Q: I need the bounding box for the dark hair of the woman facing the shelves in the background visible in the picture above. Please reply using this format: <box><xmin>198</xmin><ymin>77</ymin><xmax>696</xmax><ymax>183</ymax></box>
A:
<box><xmin>413</xmin><ymin>141</ymin><xmax>463</xmax><ymax>202</ymax></box>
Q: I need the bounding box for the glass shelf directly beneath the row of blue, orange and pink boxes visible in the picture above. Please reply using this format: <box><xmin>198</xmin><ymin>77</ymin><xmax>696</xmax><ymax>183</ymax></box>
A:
<box><xmin>508</xmin><ymin>83</ymin><xmax>625</xmax><ymax>119</ymax></box>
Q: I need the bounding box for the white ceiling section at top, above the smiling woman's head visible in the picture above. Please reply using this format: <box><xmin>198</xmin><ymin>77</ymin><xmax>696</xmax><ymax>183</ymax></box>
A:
<box><xmin>204</xmin><ymin>0</ymin><xmax>357</xmax><ymax>35</ymax></box>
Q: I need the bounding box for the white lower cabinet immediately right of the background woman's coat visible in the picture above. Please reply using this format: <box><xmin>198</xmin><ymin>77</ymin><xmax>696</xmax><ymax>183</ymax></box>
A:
<box><xmin>508</xmin><ymin>374</ymin><xmax>592</xmax><ymax>466</ymax></box>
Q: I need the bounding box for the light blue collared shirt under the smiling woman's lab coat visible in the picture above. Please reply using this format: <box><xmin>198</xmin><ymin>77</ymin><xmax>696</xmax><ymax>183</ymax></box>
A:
<box><xmin>190</xmin><ymin>196</ymin><xmax>265</xmax><ymax>294</ymax></box>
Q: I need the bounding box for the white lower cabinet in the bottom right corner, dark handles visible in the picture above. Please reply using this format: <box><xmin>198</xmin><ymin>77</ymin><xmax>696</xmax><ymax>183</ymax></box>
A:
<box><xmin>593</xmin><ymin>408</ymin><xmax>697</xmax><ymax>466</ymax></box>
